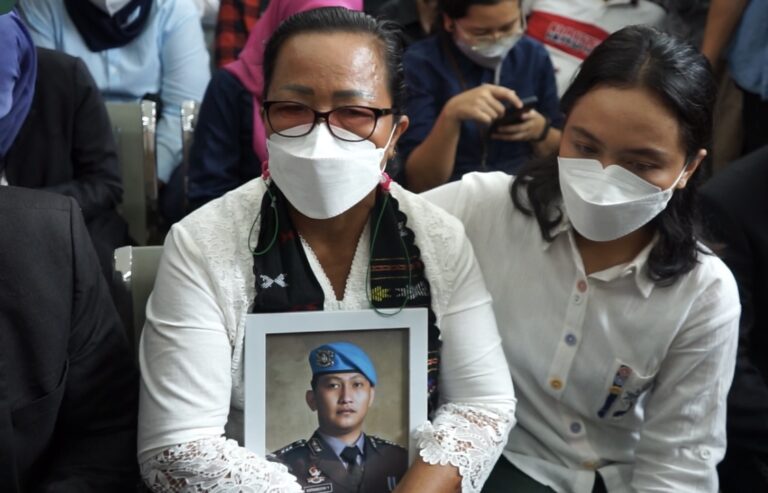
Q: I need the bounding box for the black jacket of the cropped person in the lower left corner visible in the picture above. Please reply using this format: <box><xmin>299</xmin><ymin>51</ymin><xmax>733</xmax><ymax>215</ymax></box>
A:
<box><xmin>0</xmin><ymin>187</ymin><xmax>138</xmax><ymax>493</ymax></box>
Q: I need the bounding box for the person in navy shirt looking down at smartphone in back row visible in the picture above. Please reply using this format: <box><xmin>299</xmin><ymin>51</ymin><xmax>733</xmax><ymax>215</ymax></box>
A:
<box><xmin>398</xmin><ymin>0</ymin><xmax>562</xmax><ymax>191</ymax></box>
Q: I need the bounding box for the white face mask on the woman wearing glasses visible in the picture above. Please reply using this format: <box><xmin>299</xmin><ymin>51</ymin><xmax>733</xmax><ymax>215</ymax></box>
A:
<box><xmin>267</xmin><ymin>123</ymin><xmax>397</xmax><ymax>219</ymax></box>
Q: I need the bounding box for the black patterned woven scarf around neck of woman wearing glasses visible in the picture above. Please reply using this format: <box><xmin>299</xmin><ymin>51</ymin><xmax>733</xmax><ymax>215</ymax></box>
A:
<box><xmin>252</xmin><ymin>182</ymin><xmax>441</xmax><ymax>414</ymax></box>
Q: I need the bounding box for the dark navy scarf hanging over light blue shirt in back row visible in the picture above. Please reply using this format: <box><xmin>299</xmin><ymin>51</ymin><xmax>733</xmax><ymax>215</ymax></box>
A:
<box><xmin>64</xmin><ymin>0</ymin><xmax>152</xmax><ymax>52</ymax></box>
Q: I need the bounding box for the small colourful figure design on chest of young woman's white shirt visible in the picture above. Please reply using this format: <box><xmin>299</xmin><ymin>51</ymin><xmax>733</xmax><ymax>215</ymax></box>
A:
<box><xmin>597</xmin><ymin>358</ymin><xmax>656</xmax><ymax>421</ymax></box>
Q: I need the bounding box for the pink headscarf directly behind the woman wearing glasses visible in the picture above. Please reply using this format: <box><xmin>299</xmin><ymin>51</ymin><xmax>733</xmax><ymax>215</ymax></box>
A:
<box><xmin>224</xmin><ymin>0</ymin><xmax>363</xmax><ymax>161</ymax></box>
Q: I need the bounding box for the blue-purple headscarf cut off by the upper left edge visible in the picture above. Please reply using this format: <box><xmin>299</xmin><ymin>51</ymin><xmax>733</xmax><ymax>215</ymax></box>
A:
<box><xmin>0</xmin><ymin>12</ymin><xmax>37</xmax><ymax>160</ymax></box>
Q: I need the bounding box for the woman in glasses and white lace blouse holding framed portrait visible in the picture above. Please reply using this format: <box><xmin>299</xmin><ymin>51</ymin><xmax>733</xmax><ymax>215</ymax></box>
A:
<box><xmin>139</xmin><ymin>8</ymin><xmax>515</xmax><ymax>492</ymax></box>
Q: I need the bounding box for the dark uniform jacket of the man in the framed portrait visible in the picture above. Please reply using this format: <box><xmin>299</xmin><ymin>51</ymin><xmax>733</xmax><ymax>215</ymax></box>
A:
<box><xmin>268</xmin><ymin>432</ymin><xmax>408</xmax><ymax>493</ymax></box>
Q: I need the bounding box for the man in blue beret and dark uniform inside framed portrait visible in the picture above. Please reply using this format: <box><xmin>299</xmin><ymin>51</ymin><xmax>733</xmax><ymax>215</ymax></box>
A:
<box><xmin>269</xmin><ymin>342</ymin><xmax>408</xmax><ymax>493</ymax></box>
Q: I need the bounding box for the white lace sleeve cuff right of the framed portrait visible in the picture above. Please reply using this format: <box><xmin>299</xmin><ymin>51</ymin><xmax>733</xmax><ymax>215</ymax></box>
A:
<box><xmin>415</xmin><ymin>404</ymin><xmax>514</xmax><ymax>493</ymax></box>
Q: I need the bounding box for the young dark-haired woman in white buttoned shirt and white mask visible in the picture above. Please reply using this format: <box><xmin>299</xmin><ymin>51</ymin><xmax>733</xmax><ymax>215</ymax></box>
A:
<box><xmin>426</xmin><ymin>27</ymin><xmax>740</xmax><ymax>493</ymax></box>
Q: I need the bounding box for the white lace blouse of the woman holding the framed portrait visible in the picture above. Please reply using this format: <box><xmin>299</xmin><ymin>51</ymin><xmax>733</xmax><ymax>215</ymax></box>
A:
<box><xmin>138</xmin><ymin>179</ymin><xmax>515</xmax><ymax>492</ymax></box>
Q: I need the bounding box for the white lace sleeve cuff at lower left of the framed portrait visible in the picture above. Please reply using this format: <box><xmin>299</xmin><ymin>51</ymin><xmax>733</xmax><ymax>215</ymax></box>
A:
<box><xmin>141</xmin><ymin>437</ymin><xmax>301</xmax><ymax>493</ymax></box>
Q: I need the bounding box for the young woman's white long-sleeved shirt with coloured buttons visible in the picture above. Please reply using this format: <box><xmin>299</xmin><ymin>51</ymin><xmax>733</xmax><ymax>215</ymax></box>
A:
<box><xmin>425</xmin><ymin>173</ymin><xmax>740</xmax><ymax>493</ymax></box>
